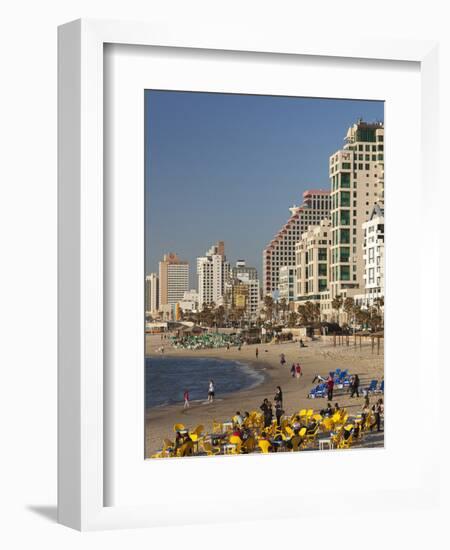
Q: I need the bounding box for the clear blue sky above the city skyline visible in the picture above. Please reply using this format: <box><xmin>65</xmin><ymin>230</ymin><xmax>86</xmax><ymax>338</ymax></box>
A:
<box><xmin>145</xmin><ymin>90</ymin><xmax>384</xmax><ymax>288</ymax></box>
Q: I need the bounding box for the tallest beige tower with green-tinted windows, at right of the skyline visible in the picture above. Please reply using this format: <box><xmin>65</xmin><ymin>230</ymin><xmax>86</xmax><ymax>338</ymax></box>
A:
<box><xmin>329</xmin><ymin>120</ymin><xmax>384</xmax><ymax>298</ymax></box>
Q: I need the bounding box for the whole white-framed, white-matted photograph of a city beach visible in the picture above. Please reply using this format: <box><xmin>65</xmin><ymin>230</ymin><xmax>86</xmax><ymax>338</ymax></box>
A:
<box><xmin>58</xmin><ymin>20</ymin><xmax>439</xmax><ymax>530</ymax></box>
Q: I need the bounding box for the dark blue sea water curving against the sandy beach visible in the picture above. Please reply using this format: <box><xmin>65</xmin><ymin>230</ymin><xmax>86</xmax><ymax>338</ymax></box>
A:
<box><xmin>145</xmin><ymin>356</ymin><xmax>264</xmax><ymax>408</ymax></box>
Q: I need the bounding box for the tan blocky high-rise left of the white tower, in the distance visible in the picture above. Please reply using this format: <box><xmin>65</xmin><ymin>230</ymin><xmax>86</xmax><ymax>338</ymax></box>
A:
<box><xmin>159</xmin><ymin>252</ymin><xmax>189</xmax><ymax>306</ymax></box>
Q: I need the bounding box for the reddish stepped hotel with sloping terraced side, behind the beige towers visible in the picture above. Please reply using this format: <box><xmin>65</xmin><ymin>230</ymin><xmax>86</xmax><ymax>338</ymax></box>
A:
<box><xmin>263</xmin><ymin>190</ymin><xmax>331</xmax><ymax>295</ymax></box>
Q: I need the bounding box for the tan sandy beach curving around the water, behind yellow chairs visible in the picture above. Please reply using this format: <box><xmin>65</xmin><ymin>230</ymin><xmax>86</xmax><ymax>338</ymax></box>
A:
<box><xmin>145</xmin><ymin>335</ymin><xmax>384</xmax><ymax>457</ymax></box>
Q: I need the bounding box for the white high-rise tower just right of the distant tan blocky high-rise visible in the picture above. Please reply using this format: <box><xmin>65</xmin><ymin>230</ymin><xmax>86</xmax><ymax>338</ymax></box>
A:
<box><xmin>197</xmin><ymin>241</ymin><xmax>230</xmax><ymax>309</ymax></box>
